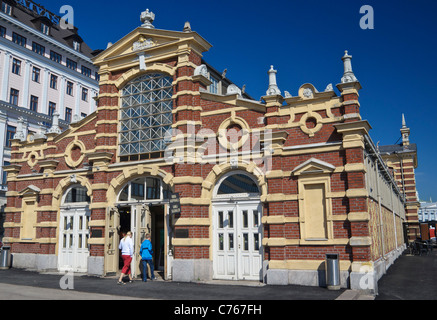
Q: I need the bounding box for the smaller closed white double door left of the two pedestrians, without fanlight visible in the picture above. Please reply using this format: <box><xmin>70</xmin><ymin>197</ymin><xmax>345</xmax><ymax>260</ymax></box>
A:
<box><xmin>59</xmin><ymin>207</ymin><xmax>91</xmax><ymax>272</ymax></box>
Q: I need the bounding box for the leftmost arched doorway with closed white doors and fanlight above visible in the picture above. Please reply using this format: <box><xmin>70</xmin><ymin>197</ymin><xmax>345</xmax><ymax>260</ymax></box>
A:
<box><xmin>58</xmin><ymin>185</ymin><xmax>91</xmax><ymax>272</ymax></box>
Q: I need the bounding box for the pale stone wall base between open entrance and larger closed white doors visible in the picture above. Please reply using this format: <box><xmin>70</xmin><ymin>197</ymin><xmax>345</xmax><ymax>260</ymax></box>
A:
<box><xmin>172</xmin><ymin>259</ymin><xmax>213</xmax><ymax>282</ymax></box>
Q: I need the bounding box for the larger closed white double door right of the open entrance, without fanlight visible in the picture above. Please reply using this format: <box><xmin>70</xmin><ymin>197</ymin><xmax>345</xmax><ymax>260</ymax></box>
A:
<box><xmin>213</xmin><ymin>202</ymin><xmax>263</xmax><ymax>280</ymax></box>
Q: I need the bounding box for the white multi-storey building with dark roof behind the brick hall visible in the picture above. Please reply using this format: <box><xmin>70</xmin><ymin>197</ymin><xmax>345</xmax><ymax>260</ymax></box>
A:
<box><xmin>0</xmin><ymin>0</ymin><xmax>99</xmax><ymax>240</ymax></box>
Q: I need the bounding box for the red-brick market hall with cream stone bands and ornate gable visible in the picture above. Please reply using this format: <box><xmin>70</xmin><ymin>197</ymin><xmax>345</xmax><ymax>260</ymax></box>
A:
<box><xmin>5</xmin><ymin>11</ymin><xmax>405</xmax><ymax>289</ymax></box>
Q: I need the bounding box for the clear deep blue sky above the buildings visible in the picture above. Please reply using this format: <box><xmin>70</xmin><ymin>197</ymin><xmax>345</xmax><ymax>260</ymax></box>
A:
<box><xmin>42</xmin><ymin>0</ymin><xmax>437</xmax><ymax>201</ymax></box>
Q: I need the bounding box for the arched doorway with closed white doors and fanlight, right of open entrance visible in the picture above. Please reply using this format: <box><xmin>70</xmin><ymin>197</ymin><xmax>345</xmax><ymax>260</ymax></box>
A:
<box><xmin>212</xmin><ymin>171</ymin><xmax>263</xmax><ymax>280</ymax></box>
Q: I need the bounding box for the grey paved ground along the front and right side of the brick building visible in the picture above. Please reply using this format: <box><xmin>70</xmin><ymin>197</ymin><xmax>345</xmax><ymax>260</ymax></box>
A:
<box><xmin>0</xmin><ymin>249</ymin><xmax>430</xmax><ymax>304</ymax></box>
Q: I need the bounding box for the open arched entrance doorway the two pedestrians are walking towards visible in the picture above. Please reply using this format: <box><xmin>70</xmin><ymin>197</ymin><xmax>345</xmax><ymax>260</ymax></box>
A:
<box><xmin>107</xmin><ymin>177</ymin><xmax>171</xmax><ymax>278</ymax></box>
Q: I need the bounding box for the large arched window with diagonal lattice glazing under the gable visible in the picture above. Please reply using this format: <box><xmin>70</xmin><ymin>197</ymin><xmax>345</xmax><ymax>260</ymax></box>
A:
<box><xmin>119</xmin><ymin>74</ymin><xmax>173</xmax><ymax>161</ymax></box>
